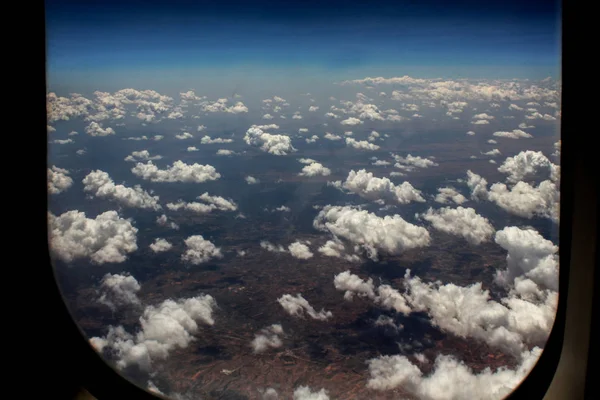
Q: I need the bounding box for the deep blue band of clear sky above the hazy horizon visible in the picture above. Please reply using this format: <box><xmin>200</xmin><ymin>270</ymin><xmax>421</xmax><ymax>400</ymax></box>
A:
<box><xmin>46</xmin><ymin>0</ymin><xmax>561</xmax><ymax>89</ymax></box>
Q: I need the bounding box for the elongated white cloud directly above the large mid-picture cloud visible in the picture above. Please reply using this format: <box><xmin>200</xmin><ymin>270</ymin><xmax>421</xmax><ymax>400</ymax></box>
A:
<box><xmin>340</xmin><ymin>169</ymin><xmax>425</xmax><ymax>204</ymax></box>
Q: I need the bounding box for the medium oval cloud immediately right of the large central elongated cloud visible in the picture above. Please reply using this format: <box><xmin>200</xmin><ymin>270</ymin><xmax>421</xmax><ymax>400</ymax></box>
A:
<box><xmin>421</xmin><ymin>207</ymin><xmax>495</xmax><ymax>245</ymax></box>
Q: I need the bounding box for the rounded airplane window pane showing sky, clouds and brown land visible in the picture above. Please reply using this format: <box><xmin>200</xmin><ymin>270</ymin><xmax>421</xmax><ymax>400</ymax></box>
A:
<box><xmin>46</xmin><ymin>0</ymin><xmax>562</xmax><ymax>400</ymax></box>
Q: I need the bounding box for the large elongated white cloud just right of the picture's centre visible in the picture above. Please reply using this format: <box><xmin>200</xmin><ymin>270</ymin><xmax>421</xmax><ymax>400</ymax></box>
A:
<box><xmin>313</xmin><ymin>206</ymin><xmax>430</xmax><ymax>260</ymax></box>
